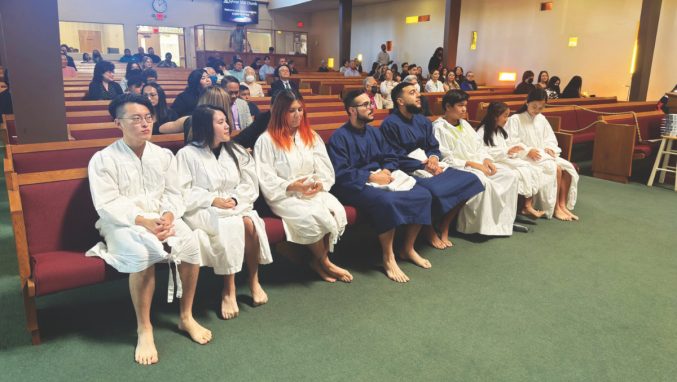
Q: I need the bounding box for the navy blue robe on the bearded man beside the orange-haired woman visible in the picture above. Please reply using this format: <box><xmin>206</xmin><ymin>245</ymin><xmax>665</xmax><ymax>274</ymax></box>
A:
<box><xmin>327</xmin><ymin>122</ymin><xmax>432</xmax><ymax>234</ymax></box>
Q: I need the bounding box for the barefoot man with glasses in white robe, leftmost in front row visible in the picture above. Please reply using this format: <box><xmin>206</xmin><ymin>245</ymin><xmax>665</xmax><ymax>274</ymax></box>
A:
<box><xmin>87</xmin><ymin>94</ymin><xmax>212</xmax><ymax>365</ymax></box>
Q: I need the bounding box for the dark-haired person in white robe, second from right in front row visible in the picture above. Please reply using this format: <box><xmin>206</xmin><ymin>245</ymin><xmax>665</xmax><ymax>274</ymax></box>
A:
<box><xmin>477</xmin><ymin>101</ymin><xmax>549</xmax><ymax>219</ymax></box>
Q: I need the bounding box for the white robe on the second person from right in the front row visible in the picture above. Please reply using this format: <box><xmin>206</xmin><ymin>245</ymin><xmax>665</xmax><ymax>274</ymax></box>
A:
<box><xmin>477</xmin><ymin>127</ymin><xmax>556</xmax><ymax>198</ymax></box>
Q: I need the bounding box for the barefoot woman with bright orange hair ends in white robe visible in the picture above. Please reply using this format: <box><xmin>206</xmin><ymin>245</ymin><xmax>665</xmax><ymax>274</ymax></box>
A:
<box><xmin>254</xmin><ymin>90</ymin><xmax>353</xmax><ymax>282</ymax></box>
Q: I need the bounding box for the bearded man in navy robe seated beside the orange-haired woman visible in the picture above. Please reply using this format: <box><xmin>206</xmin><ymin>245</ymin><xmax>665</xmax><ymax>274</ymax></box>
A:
<box><xmin>327</xmin><ymin>90</ymin><xmax>432</xmax><ymax>282</ymax></box>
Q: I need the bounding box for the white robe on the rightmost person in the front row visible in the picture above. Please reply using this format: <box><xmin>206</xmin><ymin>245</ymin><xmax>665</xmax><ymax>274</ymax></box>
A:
<box><xmin>505</xmin><ymin>111</ymin><xmax>579</xmax><ymax>213</ymax></box>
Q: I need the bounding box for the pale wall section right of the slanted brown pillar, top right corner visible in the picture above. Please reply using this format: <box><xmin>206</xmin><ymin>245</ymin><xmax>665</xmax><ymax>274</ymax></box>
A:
<box><xmin>647</xmin><ymin>0</ymin><xmax>677</xmax><ymax>100</ymax></box>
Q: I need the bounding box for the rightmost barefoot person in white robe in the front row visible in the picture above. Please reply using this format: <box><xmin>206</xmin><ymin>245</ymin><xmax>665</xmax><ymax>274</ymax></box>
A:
<box><xmin>505</xmin><ymin>89</ymin><xmax>578</xmax><ymax>221</ymax></box>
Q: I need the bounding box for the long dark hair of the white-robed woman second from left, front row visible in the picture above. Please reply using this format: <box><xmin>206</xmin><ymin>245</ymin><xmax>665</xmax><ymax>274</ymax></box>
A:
<box><xmin>186</xmin><ymin>105</ymin><xmax>244</xmax><ymax>171</ymax></box>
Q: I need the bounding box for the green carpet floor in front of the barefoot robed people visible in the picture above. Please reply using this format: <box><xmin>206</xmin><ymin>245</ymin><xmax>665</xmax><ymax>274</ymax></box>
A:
<box><xmin>0</xmin><ymin>177</ymin><xmax>677</xmax><ymax>381</ymax></box>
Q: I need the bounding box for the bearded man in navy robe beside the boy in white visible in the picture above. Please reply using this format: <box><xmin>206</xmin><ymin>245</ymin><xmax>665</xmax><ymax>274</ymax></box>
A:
<box><xmin>380</xmin><ymin>82</ymin><xmax>484</xmax><ymax>249</ymax></box>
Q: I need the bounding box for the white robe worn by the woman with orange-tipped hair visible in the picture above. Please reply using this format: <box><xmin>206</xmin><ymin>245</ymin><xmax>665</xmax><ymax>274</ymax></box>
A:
<box><xmin>254</xmin><ymin>132</ymin><xmax>347</xmax><ymax>251</ymax></box>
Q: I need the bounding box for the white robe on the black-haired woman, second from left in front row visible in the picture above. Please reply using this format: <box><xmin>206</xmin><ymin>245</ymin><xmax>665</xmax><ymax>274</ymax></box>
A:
<box><xmin>176</xmin><ymin>145</ymin><xmax>273</xmax><ymax>275</ymax></box>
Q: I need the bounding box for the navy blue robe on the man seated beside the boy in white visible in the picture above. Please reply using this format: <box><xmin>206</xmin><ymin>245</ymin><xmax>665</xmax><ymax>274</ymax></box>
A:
<box><xmin>380</xmin><ymin>111</ymin><xmax>484</xmax><ymax>214</ymax></box>
